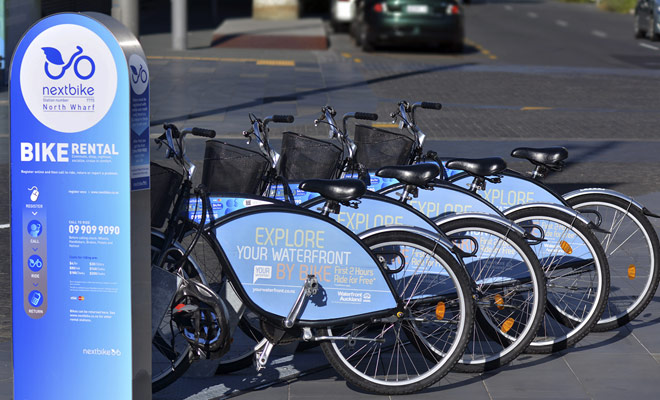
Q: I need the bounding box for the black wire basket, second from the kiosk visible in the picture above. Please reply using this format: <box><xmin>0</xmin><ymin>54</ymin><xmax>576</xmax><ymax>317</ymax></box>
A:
<box><xmin>202</xmin><ymin>140</ymin><xmax>270</xmax><ymax>195</ymax></box>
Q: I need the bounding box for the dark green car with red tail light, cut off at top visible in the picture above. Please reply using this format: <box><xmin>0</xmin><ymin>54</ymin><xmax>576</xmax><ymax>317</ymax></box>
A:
<box><xmin>351</xmin><ymin>0</ymin><xmax>464</xmax><ymax>51</ymax></box>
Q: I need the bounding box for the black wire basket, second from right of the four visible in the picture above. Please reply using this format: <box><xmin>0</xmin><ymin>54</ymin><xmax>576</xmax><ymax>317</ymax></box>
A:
<box><xmin>280</xmin><ymin>132</ymin><xmax>342</xmax><ymax>180</ymax></box>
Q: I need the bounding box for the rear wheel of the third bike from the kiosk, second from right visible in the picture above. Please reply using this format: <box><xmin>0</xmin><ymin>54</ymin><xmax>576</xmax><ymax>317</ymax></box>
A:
<box><xmin>505</xmin><ymin>207</ymin><xmax>610</xmax><ymax>353</ymax></box>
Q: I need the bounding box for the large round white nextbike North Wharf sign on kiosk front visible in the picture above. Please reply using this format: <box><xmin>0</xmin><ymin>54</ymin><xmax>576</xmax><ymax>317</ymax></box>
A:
<box><xmin>20</xmin><ymin>24</ymin><xmax>117</xmax><ymax>132</ymax></box>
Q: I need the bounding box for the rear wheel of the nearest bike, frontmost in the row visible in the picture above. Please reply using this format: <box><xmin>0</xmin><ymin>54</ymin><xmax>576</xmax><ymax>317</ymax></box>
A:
<box><xmin>320</xmin><ymin>229</ymin><xmax>474</xmax><ymax>395</ymax></box>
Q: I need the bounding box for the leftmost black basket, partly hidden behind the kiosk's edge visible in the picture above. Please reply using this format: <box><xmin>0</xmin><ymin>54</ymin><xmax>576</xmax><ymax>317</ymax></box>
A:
<box><xmin>150</xmin><ymin>162</ymin><xmax>183</xmax><ymax>228</ymax></box>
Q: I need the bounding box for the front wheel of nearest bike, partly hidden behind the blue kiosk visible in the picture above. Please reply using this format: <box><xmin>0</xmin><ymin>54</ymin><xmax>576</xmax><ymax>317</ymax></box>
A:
<box><xmin>151</xmin><ymin>233</ymin><xmax>205</xmax><ymax>393</ymax></box>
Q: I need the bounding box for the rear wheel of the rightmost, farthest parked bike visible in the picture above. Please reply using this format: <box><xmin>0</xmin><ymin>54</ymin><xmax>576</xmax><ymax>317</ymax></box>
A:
<box><xmin>567</xmin><ymin>194</ymin><xmax>660</xmax><ymax>332</ymax></box>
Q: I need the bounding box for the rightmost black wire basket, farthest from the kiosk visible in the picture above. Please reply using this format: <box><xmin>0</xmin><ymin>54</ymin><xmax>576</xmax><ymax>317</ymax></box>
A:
<box><xmin>355</xmin><ymin>125</ymin><xmax>414</xmax><ymax>169</ymax></box>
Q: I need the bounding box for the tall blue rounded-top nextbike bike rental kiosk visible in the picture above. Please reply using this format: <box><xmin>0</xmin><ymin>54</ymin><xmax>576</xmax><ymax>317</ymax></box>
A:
<box><xmin>10</xmin><ymin>13</ymin><xmax>151</xmax><ymax>400</ymax></box>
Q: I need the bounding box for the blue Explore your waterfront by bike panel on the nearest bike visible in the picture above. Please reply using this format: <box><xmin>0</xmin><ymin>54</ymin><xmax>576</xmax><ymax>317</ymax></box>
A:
<box><xmin>217</xmin><ymin>212</ymin><xmax>396</xmax><ymax>320</ymax></box>
